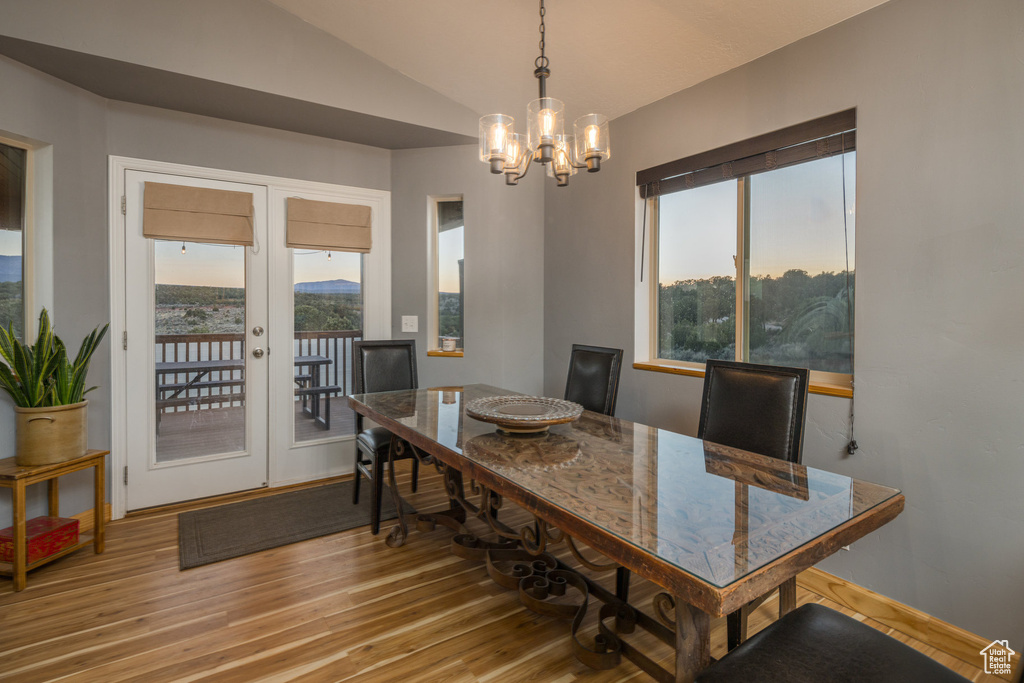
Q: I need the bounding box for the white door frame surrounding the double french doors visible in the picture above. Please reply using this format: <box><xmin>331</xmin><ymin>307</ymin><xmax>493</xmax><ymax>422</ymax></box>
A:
<box><xmin>108</xmin><ymin>156</ymin><xmax>391</xmax><ymax>519</ymax></box>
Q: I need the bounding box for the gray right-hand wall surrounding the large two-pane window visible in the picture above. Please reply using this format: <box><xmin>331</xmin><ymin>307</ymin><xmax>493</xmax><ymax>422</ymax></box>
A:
<box><xmin>545</xmin><ymin>0</ymin><xmax>1024</xmax><ymax>649</ymax></box>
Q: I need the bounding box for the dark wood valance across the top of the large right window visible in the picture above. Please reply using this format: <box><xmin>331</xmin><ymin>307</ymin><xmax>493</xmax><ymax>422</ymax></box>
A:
<box><xmin>637</xmin><ymin>110</ymin><xmax>857</xmax><ymax>199</ymax></box>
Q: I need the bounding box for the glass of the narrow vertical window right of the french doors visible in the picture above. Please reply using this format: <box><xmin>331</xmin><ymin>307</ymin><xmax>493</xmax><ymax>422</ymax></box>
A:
<box><xmin>437</xmin><ymin>200</ymin><xmax>466</xmax><ymax>350</ymax></box>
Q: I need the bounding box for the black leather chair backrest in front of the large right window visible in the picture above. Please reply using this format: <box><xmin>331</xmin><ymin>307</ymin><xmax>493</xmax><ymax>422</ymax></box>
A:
<box><xmin>697</xmin><ymin>360</ymin><xmax>810</xmax><ymax>463</ymax></box>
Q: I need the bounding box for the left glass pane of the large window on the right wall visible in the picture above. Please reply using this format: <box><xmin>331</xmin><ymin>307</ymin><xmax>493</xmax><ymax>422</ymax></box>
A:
<box><xmin>657</xmin><ymin>180</ymin><xmax>737</xmax><ymax>362</ymax></box>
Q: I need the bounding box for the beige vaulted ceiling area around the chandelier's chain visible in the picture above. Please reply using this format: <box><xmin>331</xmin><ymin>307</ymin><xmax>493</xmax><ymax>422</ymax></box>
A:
<box><xmin>270</xmin><ymin>0</ymin><xmax>885</xmax><ymax>120</ymax></box>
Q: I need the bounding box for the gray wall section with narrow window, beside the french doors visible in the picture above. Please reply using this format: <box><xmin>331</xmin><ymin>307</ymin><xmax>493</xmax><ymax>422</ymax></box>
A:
<box><xmin>391</xmin><ymin>146</ymin><xmax>544</xmax><ymax>393</ymax></box>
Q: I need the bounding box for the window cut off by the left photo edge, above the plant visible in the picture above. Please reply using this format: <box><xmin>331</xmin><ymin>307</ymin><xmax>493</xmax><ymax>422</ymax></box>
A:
<box><xmin>0</xmin><ymin>142</ymin><xmax>29</xmax><ymax>338</ymax></box>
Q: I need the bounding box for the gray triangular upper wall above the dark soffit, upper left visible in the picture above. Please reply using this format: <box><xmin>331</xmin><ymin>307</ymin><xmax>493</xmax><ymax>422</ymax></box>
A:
<box><xmin>0</xmin><ymin>0</ymin><xmax>477</xmax><ymax>135</ymax></box>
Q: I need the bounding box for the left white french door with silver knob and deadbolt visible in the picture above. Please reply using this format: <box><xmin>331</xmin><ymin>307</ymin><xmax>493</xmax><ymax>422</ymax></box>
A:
<box><xmin>125</xmin><ymin>171</ymin><xmax>269</xmax><ymax>510</ymax></box>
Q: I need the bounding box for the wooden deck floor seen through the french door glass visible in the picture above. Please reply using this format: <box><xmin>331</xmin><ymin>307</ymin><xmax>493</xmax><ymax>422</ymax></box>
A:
<box><xmin>157</xmin><ymin>396</ymin><xmax>355</xmax><ymax>462</ymax></box>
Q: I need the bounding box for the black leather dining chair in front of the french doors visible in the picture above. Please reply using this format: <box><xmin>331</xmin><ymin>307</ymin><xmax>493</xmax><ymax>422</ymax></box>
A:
<box><xmin>352</xmin><ymin>339</ymin><xmax>420</xmax><ymax>535</ymax></box>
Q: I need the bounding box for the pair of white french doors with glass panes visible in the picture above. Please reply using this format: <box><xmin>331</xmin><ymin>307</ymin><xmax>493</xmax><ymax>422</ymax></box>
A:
<box><xmin>112</xmin><ymin>158</ymin><xmax>390</xmax><ymax>515</ymax></box>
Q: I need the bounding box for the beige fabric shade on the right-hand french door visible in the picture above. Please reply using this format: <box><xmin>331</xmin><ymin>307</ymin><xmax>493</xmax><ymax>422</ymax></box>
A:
<box><xmin>287</xmin><ymin>197</ymin><xmax>371</xmax><ymax>254</ymax></box>
